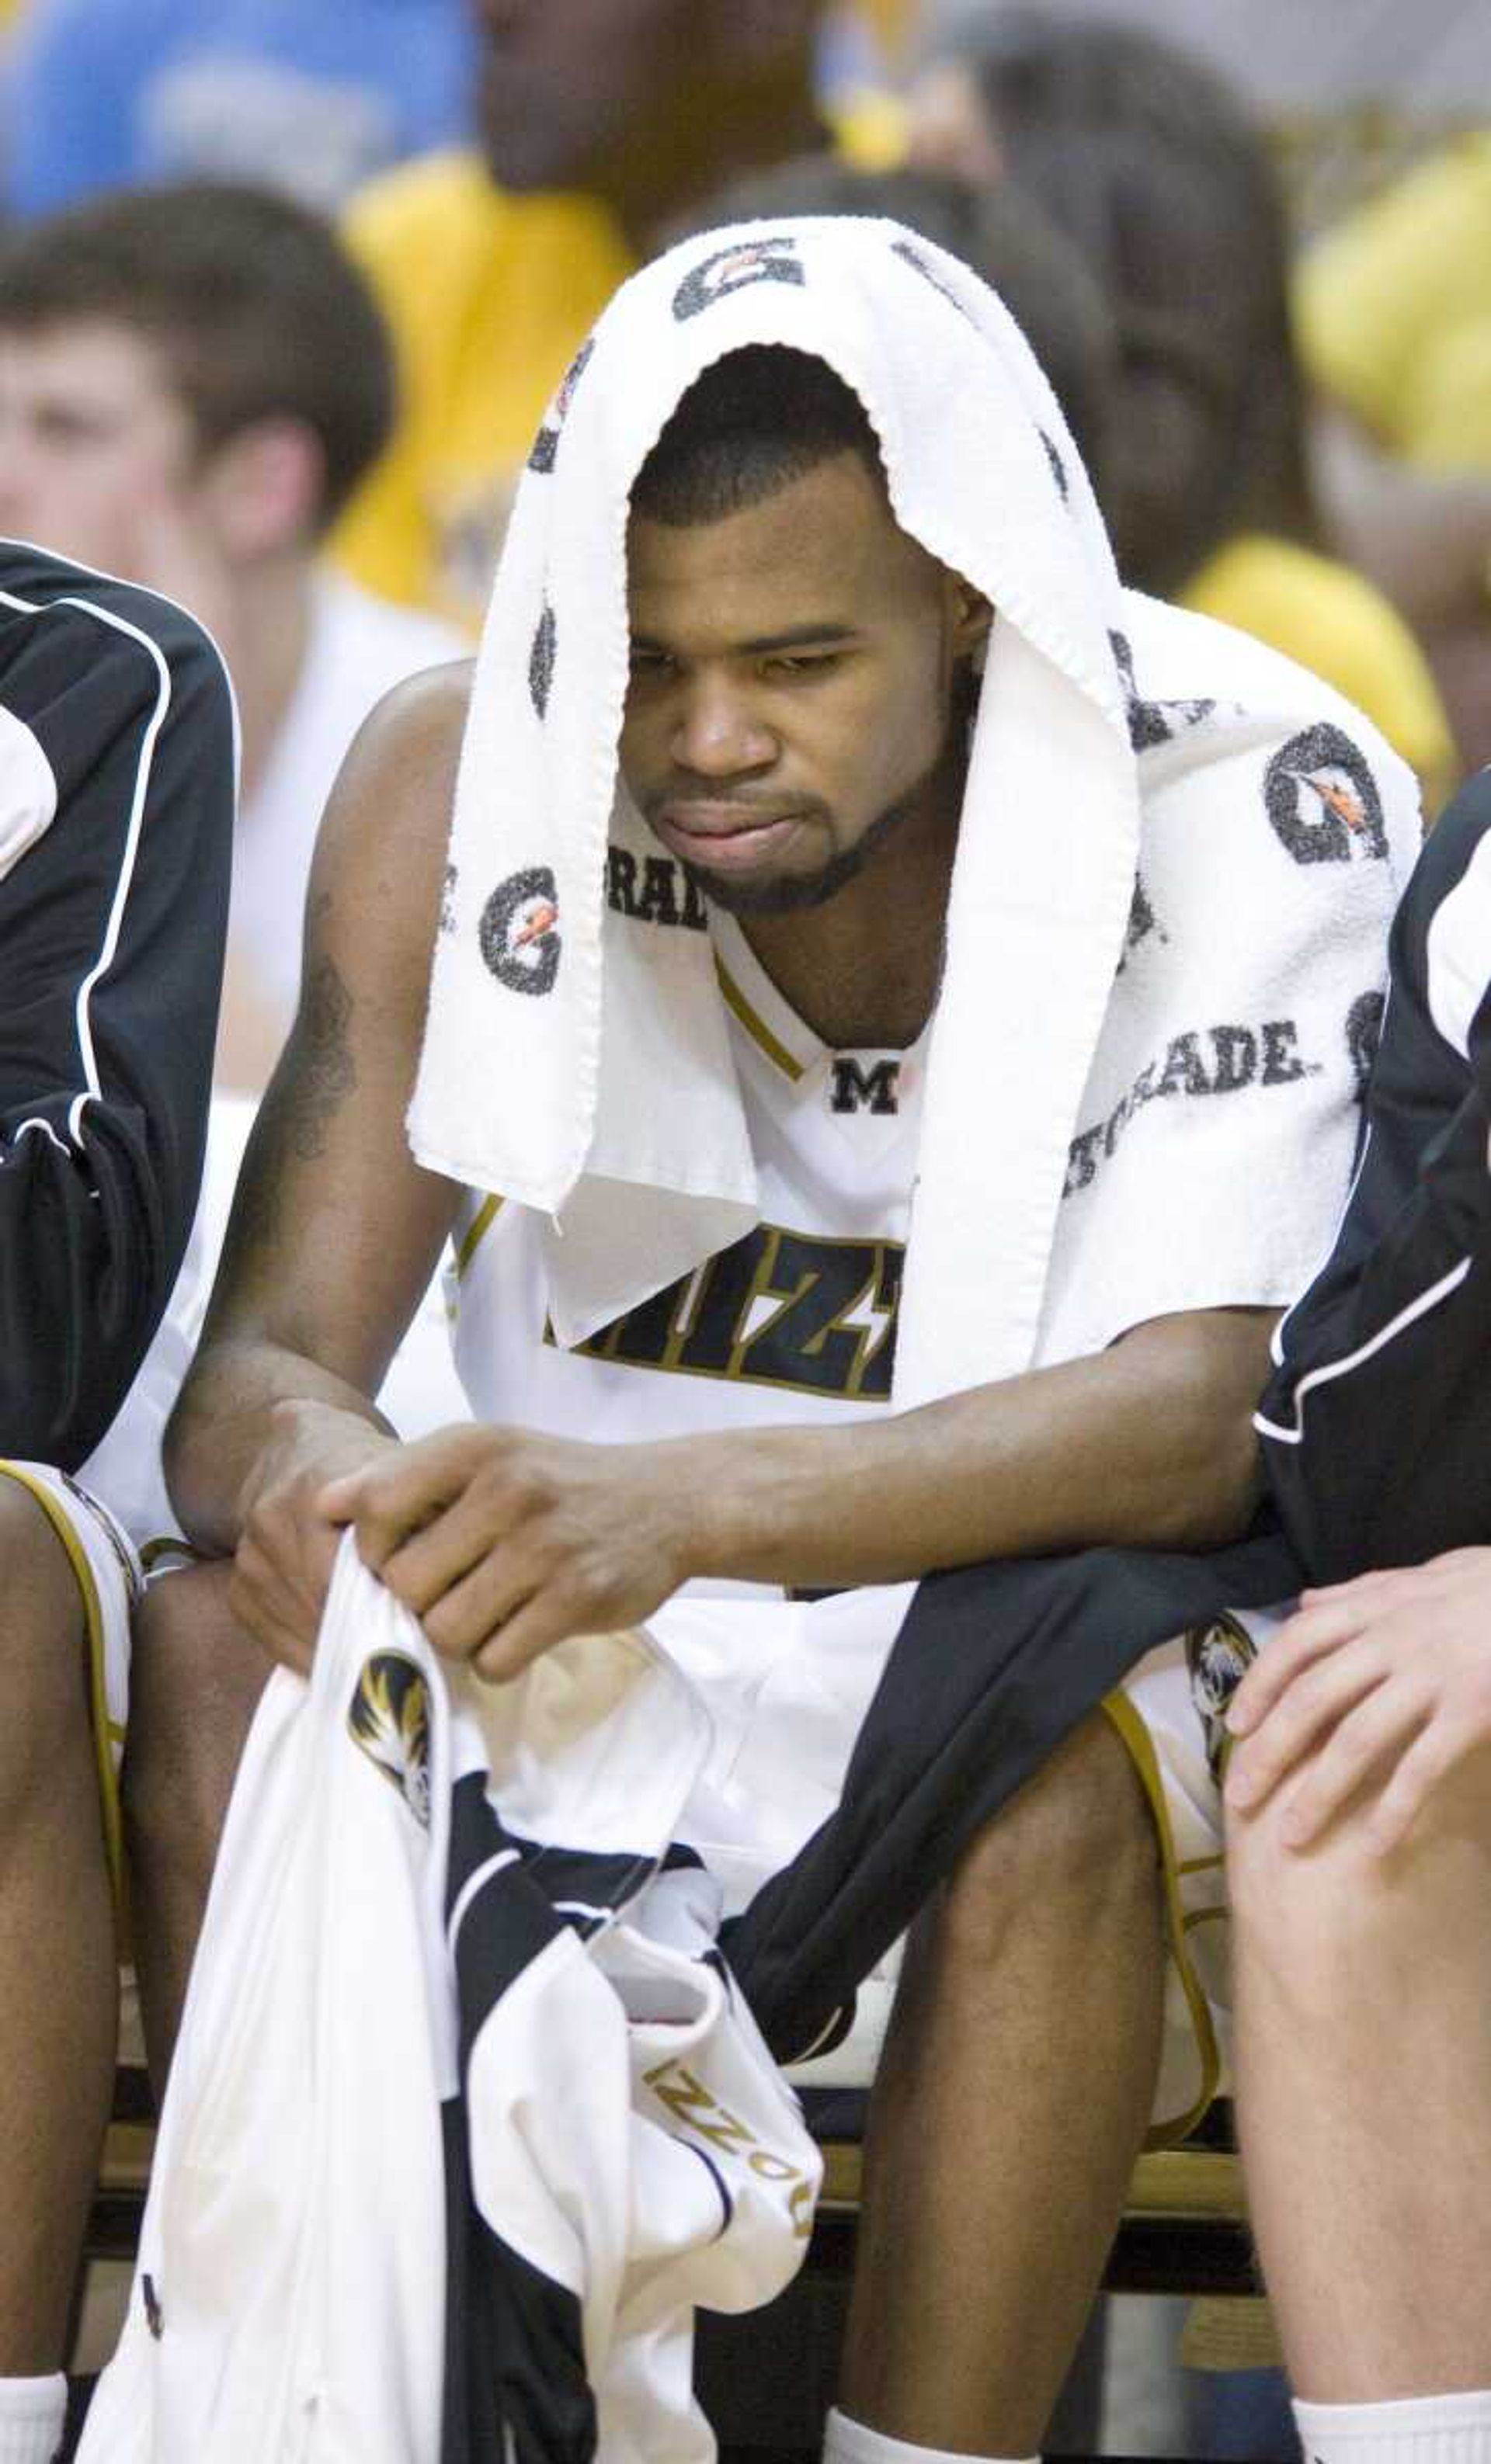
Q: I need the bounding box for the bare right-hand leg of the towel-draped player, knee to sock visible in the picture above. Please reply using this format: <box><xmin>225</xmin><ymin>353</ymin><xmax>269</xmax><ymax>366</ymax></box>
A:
<box><xmin>843</xmin><ymin>1717</ymin><xmax>1163</xmax><ymax>2456</ymax></box>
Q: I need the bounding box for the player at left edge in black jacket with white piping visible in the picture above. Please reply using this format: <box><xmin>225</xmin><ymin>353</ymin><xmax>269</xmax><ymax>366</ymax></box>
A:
<box><xmin>0</xmin><ymin>542</ymin><xmax>234</xmax><ymax>2464</ymax></box>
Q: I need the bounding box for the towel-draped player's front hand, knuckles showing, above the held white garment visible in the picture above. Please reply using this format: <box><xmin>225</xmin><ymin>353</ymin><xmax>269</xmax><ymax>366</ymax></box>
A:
<box><xmin>318</xmin><ymin>1425</ymin><xmax>693</xmax><ymax>1678</ymax></box>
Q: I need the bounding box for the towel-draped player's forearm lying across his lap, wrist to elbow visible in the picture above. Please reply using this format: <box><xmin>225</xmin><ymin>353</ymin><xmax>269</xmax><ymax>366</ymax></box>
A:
<box><xmin>678</xmin><ymin>1314</ymin><xmax>1267</xmax><ymax>1587</ymax></box>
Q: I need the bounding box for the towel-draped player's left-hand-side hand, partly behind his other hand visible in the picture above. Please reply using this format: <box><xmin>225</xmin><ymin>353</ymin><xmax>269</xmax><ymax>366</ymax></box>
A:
<box><xmin>227</xmin><ymin>1402</ymin><xmax>399</xmax><ymax>1671</ymax></box>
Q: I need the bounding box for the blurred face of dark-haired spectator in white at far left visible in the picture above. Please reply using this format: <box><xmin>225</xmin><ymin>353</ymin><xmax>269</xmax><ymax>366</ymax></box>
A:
<box><xmin>0</xmin><ymin>318</ymin><xmax>197</xmax><ymax>574</ymax></box>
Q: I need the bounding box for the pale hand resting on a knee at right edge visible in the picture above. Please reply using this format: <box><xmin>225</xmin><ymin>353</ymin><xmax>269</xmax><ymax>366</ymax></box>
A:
<box><xmin>1227</xmin><ymin>1547</ymin><xmax>1491</xmax><ymax>1855</ymax></box>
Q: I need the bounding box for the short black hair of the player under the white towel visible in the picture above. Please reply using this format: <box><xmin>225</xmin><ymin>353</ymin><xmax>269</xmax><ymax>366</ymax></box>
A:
<box><xmin>631</xmin><ymin>342</ymin><xmax>885</xmax><ymax>529</ymax></box>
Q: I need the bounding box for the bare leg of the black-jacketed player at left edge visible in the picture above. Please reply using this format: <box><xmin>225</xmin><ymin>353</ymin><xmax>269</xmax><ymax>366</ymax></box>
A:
<box><xmin>0</xmin><ymin>1481</ymin><xmax>118</xmax><ymax>2378</ymax></box>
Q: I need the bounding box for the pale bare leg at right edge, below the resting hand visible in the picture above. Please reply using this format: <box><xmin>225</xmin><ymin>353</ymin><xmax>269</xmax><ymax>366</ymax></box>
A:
<box><xmin>1227</xmin><ymin>1767</ymin><xmax>1491</xmax><ymax>2405</ymax></box>
